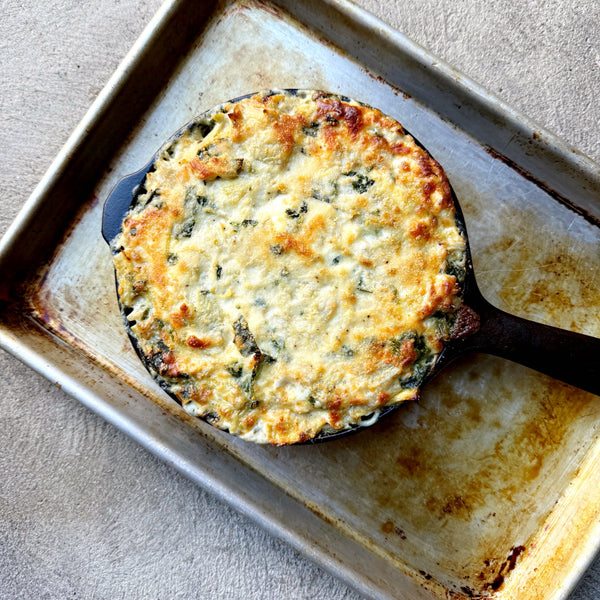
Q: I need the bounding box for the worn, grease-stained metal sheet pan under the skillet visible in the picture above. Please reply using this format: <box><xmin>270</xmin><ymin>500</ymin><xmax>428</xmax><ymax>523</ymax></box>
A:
<box><xmin>0</xmin><ymin>0</ymin><xmax>600</xmax><ymax>599</ymax></box>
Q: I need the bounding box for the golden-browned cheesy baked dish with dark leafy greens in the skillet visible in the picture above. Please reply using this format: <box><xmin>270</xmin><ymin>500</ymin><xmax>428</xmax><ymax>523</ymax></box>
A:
<box><xmin>112</xmin><ymin>90</ymin><xmax>466</xmax><ymax>444</ymax></box>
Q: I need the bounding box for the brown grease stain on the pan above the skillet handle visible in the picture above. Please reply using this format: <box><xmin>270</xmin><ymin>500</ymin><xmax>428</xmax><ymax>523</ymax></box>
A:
<box><xmin>460</xmin><ymin>182</ymin><xmax>600</xmax><ymax>337</ymax></box>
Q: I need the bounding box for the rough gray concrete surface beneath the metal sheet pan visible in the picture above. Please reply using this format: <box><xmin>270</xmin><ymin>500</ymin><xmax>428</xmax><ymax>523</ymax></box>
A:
<box><xmin>0</xmin><ymin>0</ymin><xmax>600</xmax><ymax>600</ymax></box>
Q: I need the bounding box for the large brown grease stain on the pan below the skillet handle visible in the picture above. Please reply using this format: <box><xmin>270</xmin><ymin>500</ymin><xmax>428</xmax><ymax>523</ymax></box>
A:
<box><xmin>340</xmin><ymin>355</ymin><xmax>600</xmax><ymax>593</ymax></box>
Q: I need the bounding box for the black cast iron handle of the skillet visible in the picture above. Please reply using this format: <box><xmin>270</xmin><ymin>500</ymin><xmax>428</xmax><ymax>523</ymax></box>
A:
<box><xmin>463</xmin><ymin>293</ymin><xmax>600</xmax><ymax>395</ymax></box>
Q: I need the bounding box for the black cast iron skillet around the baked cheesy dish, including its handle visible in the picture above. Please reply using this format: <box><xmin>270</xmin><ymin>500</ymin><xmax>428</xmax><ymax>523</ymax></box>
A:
<box><xmin>102</xmin><ymin>90</ymin><xmax>600</xmax><ymax>443</ymax></box>
